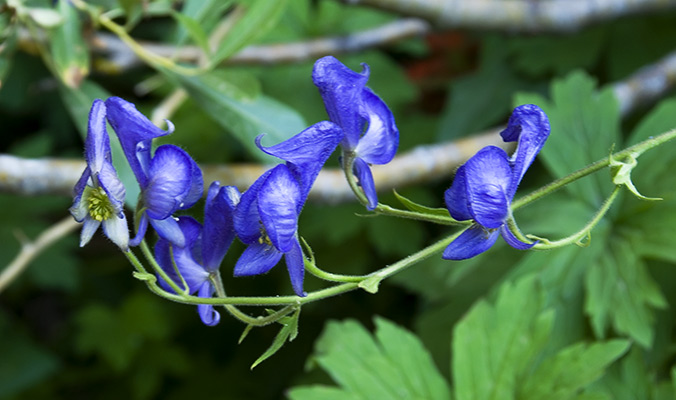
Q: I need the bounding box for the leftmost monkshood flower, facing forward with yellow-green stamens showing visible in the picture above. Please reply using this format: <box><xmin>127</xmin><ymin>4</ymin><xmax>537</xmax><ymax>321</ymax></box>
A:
<box><xmin>70</xmin><ymin>99</ymin><xmax>129</xmax><ymax>251</ymax></box>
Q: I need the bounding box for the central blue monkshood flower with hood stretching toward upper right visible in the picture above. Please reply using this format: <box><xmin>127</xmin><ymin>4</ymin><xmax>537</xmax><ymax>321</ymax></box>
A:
<box><xmin>234</xmin><ymin>121</ymin><xmax>343</xmax><ymax>296</ymax></box>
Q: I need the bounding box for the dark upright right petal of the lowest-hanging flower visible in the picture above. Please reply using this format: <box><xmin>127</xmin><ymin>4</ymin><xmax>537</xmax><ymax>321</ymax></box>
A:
<box><xmin>202</xmin><ymin>182</ymin><xmax>239</xmax><ymax>272</ymax></box>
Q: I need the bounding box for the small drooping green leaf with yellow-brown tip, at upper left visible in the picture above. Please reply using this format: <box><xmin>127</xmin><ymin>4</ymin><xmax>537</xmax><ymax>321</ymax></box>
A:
<box><xmin>49</xmin><ymin>1</ymin><xmax>89</xmax><ymax>88</ymax></box>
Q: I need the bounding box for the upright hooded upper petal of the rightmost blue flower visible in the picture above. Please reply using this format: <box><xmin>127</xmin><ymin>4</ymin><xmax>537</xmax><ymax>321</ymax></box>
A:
<box><xmin>500</xmin><ymin>104</ymin><xmax>550</xmax><ymax>195</ymax></box>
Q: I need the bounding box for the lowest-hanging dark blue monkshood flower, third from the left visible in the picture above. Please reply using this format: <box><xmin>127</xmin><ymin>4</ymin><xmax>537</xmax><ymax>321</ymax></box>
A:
<box><xmin>155</xmin><ymin>182</ymin><xmax>240</xmax><ymax>326</ymax></box>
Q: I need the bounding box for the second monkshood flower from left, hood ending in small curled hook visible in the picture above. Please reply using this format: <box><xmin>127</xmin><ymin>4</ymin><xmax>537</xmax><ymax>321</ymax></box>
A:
<box><xmin>106</xmin><ymin>97</ymin><xmax>204</xmax><ymax>247</ymax></box>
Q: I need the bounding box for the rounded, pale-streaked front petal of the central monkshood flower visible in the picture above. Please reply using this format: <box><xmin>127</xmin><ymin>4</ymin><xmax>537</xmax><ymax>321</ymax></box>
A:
<box><xmin>258</xmin><ymin>165</ymin><xmax>302</xmax><ymax>253</ymax></box>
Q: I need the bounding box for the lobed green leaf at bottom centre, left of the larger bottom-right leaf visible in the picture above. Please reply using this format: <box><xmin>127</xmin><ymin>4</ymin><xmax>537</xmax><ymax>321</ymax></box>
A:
<box><xmin>289</xmin><ymin>318</ymin><xmax>450</xmax><ymax>400</ymax></box>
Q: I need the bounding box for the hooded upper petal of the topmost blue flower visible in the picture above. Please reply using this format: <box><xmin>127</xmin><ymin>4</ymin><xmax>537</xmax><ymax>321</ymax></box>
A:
<box><xmin>312</xmin><ymin>56</ymin><xmax>369</xmax><ymax>151</ymax></box>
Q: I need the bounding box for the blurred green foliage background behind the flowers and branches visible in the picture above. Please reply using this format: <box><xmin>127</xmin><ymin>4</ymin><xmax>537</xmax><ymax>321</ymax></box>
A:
<box><xmin>0</xmin><ymin>0</ymin><xmax>676</xmax><ymax>400</ymax></box>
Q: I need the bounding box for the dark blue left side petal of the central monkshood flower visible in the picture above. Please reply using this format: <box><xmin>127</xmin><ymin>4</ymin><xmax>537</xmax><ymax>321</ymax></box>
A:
<box><xmin>233</xmin><ymin>170</ymin><xmax>271</xmax><ymax>244</ymax></box>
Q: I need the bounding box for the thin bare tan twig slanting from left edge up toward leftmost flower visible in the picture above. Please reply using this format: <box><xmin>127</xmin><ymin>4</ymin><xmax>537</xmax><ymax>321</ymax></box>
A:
<box><xmin>0</xmin><ymin>215</ymin><xmax>80</xmax><ymax>293</ymax></box>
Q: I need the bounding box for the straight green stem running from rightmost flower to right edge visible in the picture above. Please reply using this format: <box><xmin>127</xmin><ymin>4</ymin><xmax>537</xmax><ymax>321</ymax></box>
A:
<box><xmin>512</xmin><ymin>129</ymin><xmax>676</xmax><ymax>211</ymax></box>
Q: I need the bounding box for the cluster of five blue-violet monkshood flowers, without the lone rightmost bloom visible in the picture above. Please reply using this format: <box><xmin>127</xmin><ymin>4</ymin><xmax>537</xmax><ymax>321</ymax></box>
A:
<box><xmin>71</xmin><ymin>57</ymin><xmax>399</xmax><ymax>325</ymax></box>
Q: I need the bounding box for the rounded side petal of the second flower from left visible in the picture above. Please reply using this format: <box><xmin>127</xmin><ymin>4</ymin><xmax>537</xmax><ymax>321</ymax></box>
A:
<box><xmin>142</xmin><ymin>144</ymin><xmax>192</xmax><ymax>219</ymax></box>
